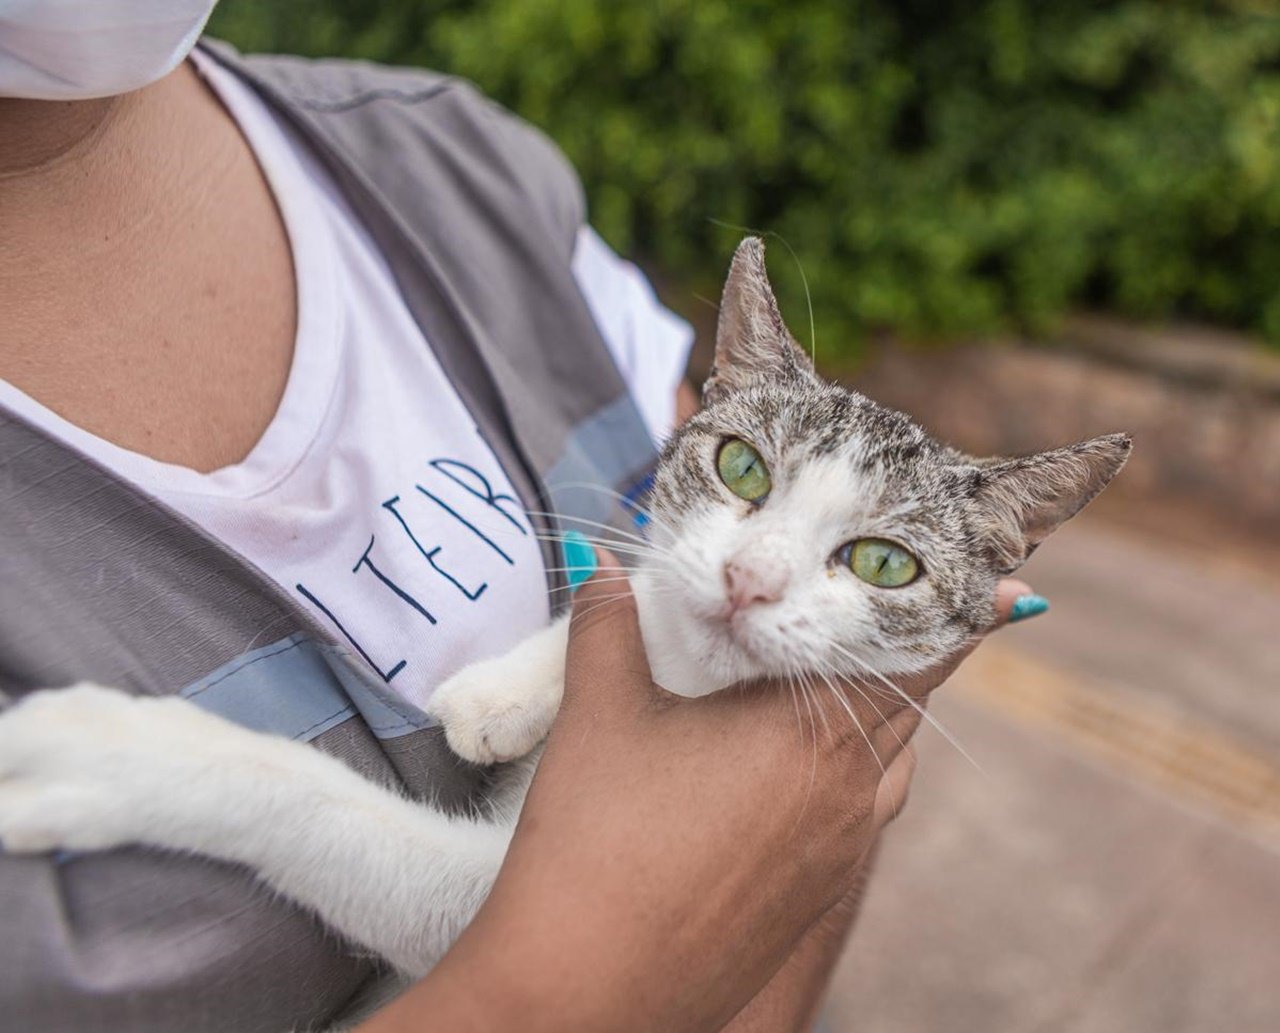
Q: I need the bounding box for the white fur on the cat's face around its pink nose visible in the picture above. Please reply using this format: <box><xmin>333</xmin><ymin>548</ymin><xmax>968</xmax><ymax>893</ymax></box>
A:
<box><xmin>645</xmin><ymin>442</ymin><xmax>947</xmax><ymax>696</ymax></box>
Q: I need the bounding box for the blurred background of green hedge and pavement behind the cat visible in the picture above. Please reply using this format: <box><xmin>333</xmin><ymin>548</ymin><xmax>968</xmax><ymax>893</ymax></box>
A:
<box><xmin>211</xmin><ymin>0</ymin><xmax>1280</xmax><ymax>1033</ymax></box>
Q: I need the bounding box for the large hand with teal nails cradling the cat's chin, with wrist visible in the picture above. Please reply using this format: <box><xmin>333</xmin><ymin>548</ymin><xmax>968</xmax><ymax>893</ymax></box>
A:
<box><xmin>369</xmin><ymin>552</ymin><xmax>1029</xmax><ymax>1033</ymax></box>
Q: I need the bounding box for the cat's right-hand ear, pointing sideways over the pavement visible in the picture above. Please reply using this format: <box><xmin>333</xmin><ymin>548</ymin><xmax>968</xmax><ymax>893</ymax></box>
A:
<box><xmin>973</xmin><ymin>434</ymin><xmax>1133</xmax><ymax>573</ymax></box>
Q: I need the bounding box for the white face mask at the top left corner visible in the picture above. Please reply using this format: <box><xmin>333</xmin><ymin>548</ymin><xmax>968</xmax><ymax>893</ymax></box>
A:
<box><xmin>0</xmin><ymin>0</ymin><xmax>218</xmax><ymax>100</ymax></box>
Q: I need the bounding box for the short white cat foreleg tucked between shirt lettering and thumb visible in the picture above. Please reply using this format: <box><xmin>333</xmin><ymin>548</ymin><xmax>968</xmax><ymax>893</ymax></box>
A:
<box><xmin>426</xmin><ymin>614</ymin><xmax>568</xmax><ymax>764</ymax></box>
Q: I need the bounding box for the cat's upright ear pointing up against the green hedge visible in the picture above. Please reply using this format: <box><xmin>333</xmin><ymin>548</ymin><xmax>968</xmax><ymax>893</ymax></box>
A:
<box><xmin>703</xmin><ymin>237</ymin><xmax>818</xmax><ymax>403</ymax></box>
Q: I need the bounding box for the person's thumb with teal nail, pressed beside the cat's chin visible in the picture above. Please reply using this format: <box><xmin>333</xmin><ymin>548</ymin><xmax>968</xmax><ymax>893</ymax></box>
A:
<box><xmin>564</xmin><ymin>547</ymin><xmax>653</xmax><ymax>705</ymax></box>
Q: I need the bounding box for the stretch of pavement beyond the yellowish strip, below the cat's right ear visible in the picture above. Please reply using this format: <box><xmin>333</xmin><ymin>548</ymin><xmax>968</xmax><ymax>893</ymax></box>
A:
<box><xmin>1010</xmin><ymin>501</ymin><xmax>1280</xmax><ymax>755</ymax></box>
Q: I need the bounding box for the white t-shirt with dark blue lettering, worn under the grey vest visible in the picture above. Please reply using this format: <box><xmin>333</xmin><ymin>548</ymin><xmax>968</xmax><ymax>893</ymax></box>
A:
<box><xmin>0</xmin><ymin>54</ymin><xmax>691</xmax><ymax>705</ymax></box>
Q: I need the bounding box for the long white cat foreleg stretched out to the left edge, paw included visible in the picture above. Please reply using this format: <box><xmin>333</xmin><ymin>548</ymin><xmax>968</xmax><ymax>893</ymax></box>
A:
<box><xmin>0</xmin><ymin>685</ymin><xmax>512</xmax><ymax>975</ymax></box>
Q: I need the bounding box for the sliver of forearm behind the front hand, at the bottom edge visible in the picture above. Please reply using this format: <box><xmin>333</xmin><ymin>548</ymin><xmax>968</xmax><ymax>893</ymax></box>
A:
<box><xmin>724</xmin><ymin>847</ymin><xmax>877</xmax><ymax>1033</ymax></box>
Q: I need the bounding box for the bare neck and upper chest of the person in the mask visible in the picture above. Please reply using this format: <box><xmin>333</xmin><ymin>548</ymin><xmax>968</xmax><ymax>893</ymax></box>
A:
<box><xmin>0</xmin><ymin>57</ymin><xmax>297</xmax><ymax>471</ymax></box>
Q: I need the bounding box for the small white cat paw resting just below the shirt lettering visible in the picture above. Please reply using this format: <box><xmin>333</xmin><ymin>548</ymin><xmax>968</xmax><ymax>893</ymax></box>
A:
<box><xmin>428</xmin><ymin>659</ymin><xmax>559</xmax><ymax>764</ymax></box>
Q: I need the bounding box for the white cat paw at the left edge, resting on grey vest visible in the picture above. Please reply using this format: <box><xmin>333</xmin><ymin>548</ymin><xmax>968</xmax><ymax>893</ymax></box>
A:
<box><xmin>0</xmin><ymin>685</ymin><xmax>238</xmax><ymax>854</ymax></box>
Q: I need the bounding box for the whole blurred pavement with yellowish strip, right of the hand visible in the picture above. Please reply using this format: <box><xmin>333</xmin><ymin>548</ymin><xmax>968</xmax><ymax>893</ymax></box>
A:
<box><xmin>828</xmin><ymin>513</ymin><xmax>1280</xmax><ymax>1033</ymax></box>
